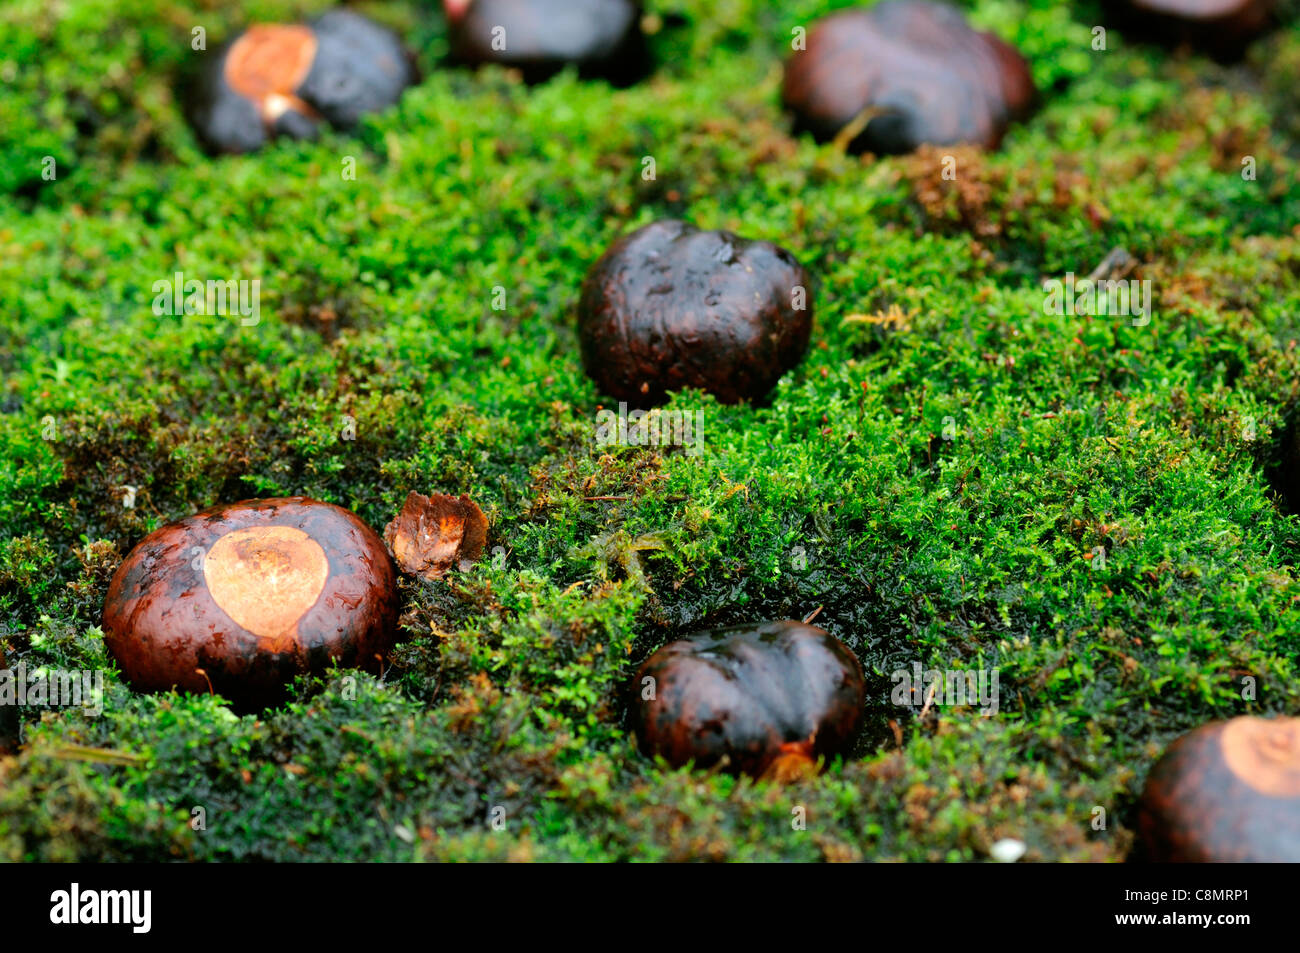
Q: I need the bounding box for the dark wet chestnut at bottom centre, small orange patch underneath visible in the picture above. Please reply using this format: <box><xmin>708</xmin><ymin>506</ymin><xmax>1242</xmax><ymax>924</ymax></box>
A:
<box><xmin>632</xmin><ymin>621</ymin><xmax>866</xmax><ymax>776</ymax></box>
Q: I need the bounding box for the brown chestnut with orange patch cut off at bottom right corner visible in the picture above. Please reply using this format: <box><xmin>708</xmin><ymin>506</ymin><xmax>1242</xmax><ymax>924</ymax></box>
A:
<box><xmin>1138</xmin><ymin>716</ymin><xmax>1300</xmax><ymax>863</ymax></box>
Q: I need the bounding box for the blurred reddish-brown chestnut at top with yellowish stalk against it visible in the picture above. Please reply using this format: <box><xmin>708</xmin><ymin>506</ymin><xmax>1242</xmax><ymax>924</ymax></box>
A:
<box><xmin>781</xmin><ymin>0</ymin><xmax>1036</xmax><ymax>155</ymax></box>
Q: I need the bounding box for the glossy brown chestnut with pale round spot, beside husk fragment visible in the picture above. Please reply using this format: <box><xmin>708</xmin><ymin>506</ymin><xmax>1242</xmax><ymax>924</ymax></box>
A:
<box><xmin>103</xmin><ymin>497</ymin><xmax>398</xmax><ymax>710</ymax></box>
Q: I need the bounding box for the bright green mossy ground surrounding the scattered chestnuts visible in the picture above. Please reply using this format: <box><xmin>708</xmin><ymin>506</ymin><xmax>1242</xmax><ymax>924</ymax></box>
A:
<box><xmin>0</xmin><ymin>0</ymin><xmax>1300</xmax><ymax>861</ymax></box>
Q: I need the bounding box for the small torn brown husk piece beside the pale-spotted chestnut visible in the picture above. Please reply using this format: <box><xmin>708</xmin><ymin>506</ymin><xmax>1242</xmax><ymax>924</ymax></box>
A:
<box><xmin>384</xmin><ymin>491</ymin><xmax>488</xmax><ymax>580</ymax></box>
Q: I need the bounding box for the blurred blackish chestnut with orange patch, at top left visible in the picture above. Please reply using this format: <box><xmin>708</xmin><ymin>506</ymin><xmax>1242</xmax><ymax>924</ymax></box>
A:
<box><xmin>187</xmin><ymin>10</ymin><xmax>416</xmax><ymax>153</ymax></box>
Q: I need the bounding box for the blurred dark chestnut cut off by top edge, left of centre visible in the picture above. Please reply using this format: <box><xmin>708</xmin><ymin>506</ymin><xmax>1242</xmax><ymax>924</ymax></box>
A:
<box><xmin>443</xmin><ymin>0</ymin><xmax>650</xmax><ymax>86</ymax></box>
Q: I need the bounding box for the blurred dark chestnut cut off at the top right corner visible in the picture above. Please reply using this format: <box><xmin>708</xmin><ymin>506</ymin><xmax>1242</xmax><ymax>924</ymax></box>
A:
<box><xmin>1106</xmin><ymin>0</ymin><xmax>1277</xmax><ymax>59</ymax></box>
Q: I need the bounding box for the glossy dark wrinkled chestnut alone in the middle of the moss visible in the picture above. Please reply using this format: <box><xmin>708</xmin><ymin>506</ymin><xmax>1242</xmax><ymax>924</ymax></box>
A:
<box><xmin>579</xmin><ymin>220</ymin><xmax>813</xmax><ymax>408</ymax></box>
